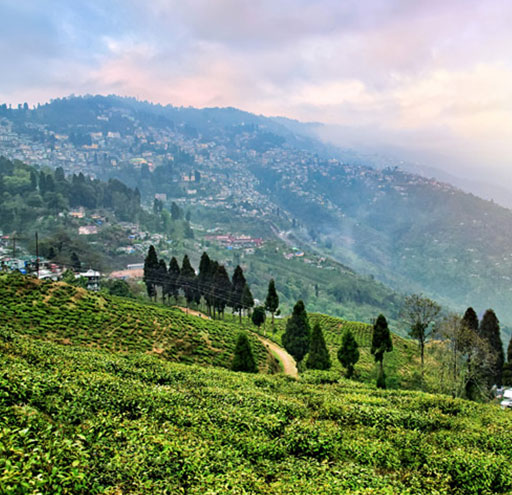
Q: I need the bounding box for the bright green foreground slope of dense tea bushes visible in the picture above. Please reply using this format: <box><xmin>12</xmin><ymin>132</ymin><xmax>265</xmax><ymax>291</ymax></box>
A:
<box><xmin>0</xmin><ymin>334</ymin><xmax>512</xmax><ymax>495</ymax></box>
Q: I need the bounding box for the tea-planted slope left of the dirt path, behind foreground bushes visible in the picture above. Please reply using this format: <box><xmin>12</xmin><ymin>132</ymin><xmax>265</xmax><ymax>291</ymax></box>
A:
<box><xmin>0</xmin><ymin>274</ymin><xmax>275</xmax><ymax>371</ymax></box>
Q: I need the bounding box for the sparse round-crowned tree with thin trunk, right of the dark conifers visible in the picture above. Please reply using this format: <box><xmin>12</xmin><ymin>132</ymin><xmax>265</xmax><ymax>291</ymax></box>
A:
<box><xmin>401</xmin><ymin>294</ymin><xmax>441</xmax><ymax>377</ymax></box>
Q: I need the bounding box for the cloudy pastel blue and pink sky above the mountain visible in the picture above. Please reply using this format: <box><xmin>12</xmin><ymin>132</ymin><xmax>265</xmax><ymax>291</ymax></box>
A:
<box><xmin>0</xmin><ymin>0</ymin><xmax>512</xmax><ymax>189</ymax></box>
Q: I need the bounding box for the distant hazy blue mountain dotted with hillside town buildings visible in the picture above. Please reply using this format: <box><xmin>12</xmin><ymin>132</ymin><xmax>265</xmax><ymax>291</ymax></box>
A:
<box><xmin>0</xmin><ymin>96</ymin><xmax>512</xmax><ymax>332</ymax></box>
